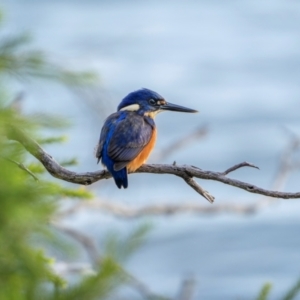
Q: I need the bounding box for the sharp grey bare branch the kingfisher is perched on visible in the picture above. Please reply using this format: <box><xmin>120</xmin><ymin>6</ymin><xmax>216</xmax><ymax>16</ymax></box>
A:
<box><xmin>8</xmin><ymin>128</ymin><xmax>300</xmax><ymax>202</ymax></box>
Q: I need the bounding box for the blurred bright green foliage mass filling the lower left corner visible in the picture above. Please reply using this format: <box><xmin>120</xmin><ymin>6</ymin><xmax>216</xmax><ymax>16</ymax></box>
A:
<box><xmin>0</xmin><ymin>59</ymin><xmax>139</xmax><ymax>300</ymax></box>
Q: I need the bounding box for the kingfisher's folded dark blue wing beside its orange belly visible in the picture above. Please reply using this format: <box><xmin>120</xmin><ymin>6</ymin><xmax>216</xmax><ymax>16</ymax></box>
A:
<box><xmin>108</xmin><ymin>113</ymin><xmax>153</xmax><ymax>171</ymax></box>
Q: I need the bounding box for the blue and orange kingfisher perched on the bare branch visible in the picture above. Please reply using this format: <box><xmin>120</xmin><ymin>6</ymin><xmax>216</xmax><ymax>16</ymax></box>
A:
<box><xmin>96</xmin><ymin>88</ymin><xmax>197</xmax><ymax>189</ymax></box>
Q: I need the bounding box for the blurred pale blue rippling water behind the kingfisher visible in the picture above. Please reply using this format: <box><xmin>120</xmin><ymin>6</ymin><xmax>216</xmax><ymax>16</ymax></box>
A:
<box><xmin>1</xmin><ymin>0</ymin><xmax>300</xmax><ymax>300</ymax></box>
